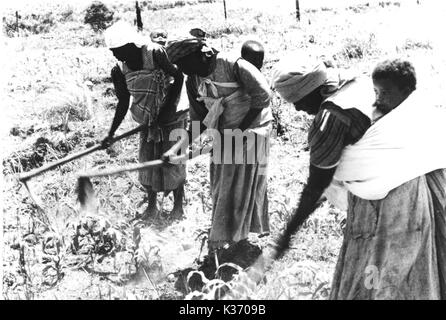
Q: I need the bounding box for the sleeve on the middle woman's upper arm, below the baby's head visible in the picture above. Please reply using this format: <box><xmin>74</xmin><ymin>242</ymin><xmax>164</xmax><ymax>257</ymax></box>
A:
<box><xmin>237</xmin><ymin>59</ymin><xmax>271</xmax><ymax>109</ymax></box>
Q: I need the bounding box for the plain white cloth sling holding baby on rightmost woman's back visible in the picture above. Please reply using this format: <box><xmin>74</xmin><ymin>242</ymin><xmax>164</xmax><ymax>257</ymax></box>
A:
<box><xmin>334</xmin><ymin>92</ymin><xmax>446</xmax><ymax>200</ymax></box>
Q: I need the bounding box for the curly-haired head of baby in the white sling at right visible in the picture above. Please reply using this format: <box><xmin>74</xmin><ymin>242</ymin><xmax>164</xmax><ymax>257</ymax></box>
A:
<box><xmin>372</xmin><ymin>59</ymin><xmax>417</xmax><ymax>115</ymax></box>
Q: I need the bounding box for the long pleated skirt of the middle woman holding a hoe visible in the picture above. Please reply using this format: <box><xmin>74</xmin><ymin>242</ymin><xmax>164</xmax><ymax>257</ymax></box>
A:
<box><xmin>209</xmin><ymin>123</ymin><xmax>271</xmax><ymax>250</ymax></box>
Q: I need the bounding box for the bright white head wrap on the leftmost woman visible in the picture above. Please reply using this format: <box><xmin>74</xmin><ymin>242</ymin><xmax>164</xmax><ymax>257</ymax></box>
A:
<box><xmin>104</xmin><ymin>21</ymin><xmax>143</xmax><ymax>49</ymax></box>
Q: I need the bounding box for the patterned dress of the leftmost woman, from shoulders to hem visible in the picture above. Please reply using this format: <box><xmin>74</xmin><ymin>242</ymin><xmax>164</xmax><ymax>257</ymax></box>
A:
<box><xmin>112</xmin><ymin>44</ymin><xmax>186</xmax><ymax>192</ymax></box>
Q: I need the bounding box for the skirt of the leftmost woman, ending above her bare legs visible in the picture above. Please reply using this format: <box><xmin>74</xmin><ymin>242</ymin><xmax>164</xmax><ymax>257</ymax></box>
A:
<box><xmin>139</xmin><ymin>120</ymin><xmax>186</xmax><ymax>192</ymax></box>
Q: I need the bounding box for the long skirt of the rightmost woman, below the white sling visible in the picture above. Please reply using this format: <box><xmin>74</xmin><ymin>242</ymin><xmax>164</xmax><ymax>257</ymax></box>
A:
<box><xmin>330</xmin><ymin>170</ymin><xmax>446</xmax><ymax>300</ymax></box>
